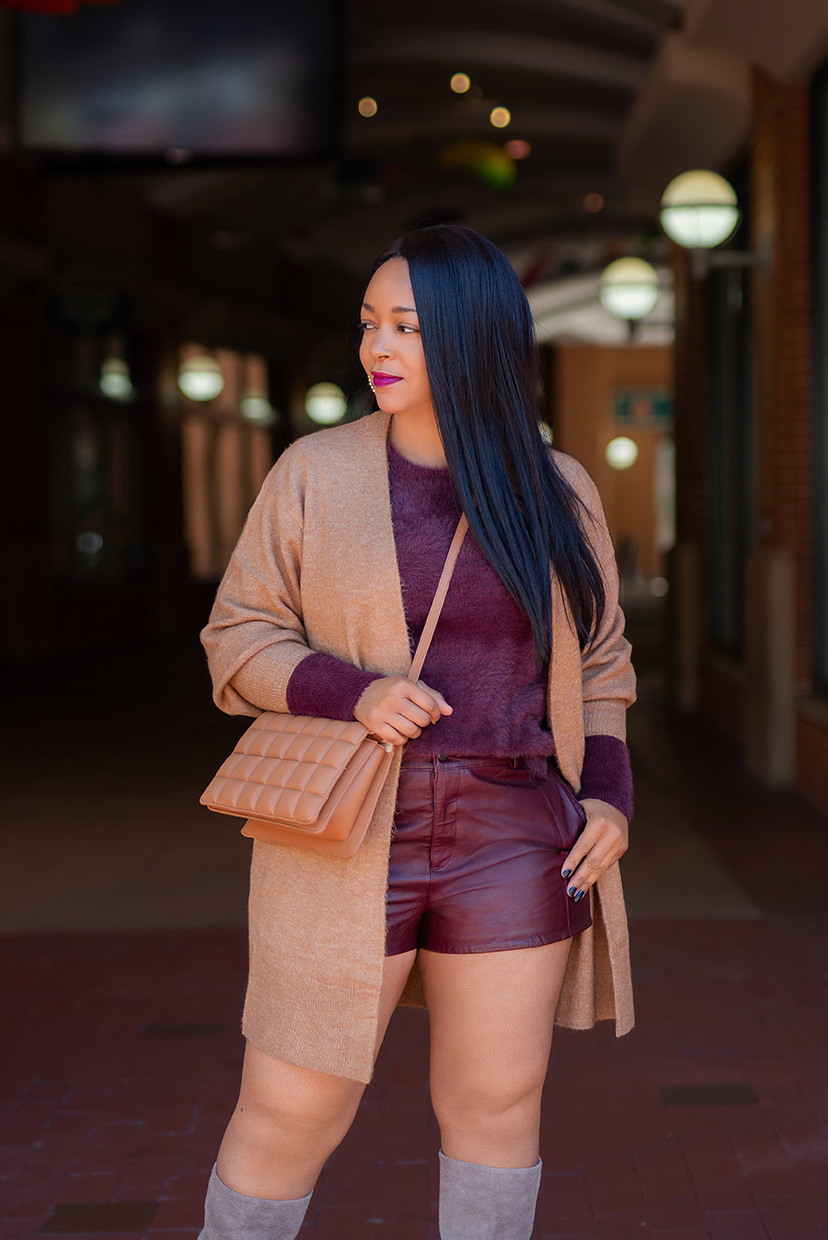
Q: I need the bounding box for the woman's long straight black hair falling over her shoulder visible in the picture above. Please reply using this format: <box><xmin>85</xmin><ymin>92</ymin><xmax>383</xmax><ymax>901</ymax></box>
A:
<box><xmin>372</xmin><ymin>224</ymin><xmax>605</xmax><ymax>665</ymax></box>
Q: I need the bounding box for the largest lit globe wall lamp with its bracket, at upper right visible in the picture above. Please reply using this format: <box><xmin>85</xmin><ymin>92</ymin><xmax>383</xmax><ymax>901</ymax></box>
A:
<box><xmin>659</xmin><ymin>169</ymin><xmax>771</xmax><ymax>279</ymax></box>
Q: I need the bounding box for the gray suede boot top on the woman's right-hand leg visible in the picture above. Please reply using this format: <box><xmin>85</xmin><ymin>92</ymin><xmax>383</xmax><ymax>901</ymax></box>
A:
<box><xmin>440</xmin><ymin>1151</ymin><xmax>540</xmax><ymax>1240</ymax></box>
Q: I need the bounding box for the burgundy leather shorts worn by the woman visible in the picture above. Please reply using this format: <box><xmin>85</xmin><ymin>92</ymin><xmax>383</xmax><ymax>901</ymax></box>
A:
<box><xmin>385</xmin><ymin>758</ymin><xmax>591</xmax><ymax>956</ymax></box>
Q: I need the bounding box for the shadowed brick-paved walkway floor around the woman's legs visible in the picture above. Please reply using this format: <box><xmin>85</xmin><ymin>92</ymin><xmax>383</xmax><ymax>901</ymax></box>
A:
<box><xmin>0</xmin><ymin>629</ymin><xmax>828</xmax><ymax>1240</ymax></box>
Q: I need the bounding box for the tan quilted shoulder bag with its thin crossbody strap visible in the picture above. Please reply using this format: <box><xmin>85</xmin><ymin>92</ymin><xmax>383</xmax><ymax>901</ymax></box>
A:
<box><xmin>201</xmin><ymin>513</ymin><xmax>469</xmax><ymax>857</ymax></box>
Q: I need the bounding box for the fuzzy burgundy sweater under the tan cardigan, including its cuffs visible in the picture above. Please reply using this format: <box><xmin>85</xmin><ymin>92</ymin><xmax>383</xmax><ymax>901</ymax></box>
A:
<box><xmin>288</xmin><ymin>441</ymin><xmax>632</xmax><ymax>818</ymax></box>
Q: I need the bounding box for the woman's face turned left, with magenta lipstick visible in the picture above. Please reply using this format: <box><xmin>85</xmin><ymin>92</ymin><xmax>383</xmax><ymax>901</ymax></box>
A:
<box><xmin>359</xmin><ymin>258</ymin><xmax>434</xmax><ymax>414</ymax></box>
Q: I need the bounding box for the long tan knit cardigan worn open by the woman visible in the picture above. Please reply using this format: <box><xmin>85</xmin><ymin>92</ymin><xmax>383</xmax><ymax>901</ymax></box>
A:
<box><xmin>202</xmin><ymin>413</ymin><xmax>635</xmax><ymax>1081</ymax></box>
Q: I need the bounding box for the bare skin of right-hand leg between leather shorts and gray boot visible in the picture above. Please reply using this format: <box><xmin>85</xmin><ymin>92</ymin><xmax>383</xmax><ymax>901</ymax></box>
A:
<box><xmin>420</xmin><ymin>940</ymin><xmax>570</xmax><ymax>1168</ymax></box>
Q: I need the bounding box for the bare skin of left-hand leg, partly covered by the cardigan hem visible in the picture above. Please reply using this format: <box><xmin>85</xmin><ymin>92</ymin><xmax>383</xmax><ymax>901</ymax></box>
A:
<box><xmin>217</xmin><ymin>951</ymin><xmax>415</xmax><ymax>1202</ymax></box>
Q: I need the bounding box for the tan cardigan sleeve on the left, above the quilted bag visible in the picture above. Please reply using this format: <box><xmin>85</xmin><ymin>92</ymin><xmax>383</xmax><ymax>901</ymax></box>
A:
<box><xmin>201</xmin><ymin>448</ymin><xmax>311</xmax><ymax>715</ymax></box>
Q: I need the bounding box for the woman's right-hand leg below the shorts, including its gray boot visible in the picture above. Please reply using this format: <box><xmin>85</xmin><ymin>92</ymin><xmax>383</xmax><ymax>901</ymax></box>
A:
<box><xmin>420</xmin><ymin>940</ymin><xmax>570</xmax><ymax>1240</ymax></box>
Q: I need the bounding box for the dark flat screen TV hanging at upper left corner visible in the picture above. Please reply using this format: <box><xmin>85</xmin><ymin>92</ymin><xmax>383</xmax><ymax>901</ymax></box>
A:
<box><xmin>16</xmin><ymin>0</ymin><xmax>340</xmax><ymax>164</ymax></box>
